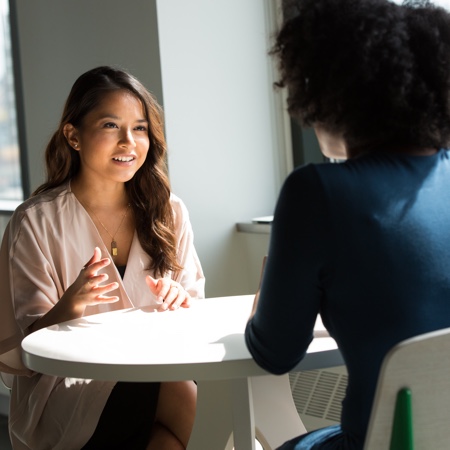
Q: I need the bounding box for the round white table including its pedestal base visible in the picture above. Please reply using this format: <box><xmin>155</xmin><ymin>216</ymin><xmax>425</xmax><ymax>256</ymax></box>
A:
<box><xmin>22</xmin><ymin>295</ymin><xmax>343</xmax><ymax>450</ymax></box>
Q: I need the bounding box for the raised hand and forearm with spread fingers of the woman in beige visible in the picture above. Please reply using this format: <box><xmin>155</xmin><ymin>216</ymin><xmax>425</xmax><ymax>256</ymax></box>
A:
<box><xmin>31</xmin><ymin>247</ymin><xmax>119</xmax><ymax>331</ymax></box>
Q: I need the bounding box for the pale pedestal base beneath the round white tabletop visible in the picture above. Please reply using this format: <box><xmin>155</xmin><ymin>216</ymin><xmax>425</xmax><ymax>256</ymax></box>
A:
<box><xmin>188</xmin><ymin>374</ymin><xmax>306</xmax><ymax>450</ymax></box>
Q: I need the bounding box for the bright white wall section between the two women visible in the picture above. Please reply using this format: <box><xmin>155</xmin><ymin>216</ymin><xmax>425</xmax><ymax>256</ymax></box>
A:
<box><xmin>157</xmin><ymin>0</ymin><xmax>287</xmax><ymax>296</ymax></box>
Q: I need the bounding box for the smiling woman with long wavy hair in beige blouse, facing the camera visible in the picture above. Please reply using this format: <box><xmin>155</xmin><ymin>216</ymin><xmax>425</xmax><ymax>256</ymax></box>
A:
<box><xmin>0</xmin><ymin>67</ymin><xmax>204</xmax><ymax>450</ymax></box>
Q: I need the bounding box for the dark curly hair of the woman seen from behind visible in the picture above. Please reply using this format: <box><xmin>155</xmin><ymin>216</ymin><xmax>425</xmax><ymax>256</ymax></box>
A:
<box><xmin>271</xmin><ymin>0</ymin><xmax>450</xmax><ymax>148</ymax></box>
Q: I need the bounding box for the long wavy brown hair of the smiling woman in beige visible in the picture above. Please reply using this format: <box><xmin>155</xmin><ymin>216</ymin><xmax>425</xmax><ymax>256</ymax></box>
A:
<box><xmin>32</xmin><ymin>66</ymin><xmax>182</xmax><ymax>276</ymax></box>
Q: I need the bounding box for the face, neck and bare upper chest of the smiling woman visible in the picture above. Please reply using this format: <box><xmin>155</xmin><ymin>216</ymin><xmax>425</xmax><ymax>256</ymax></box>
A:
<box><xmin>64</xmin><ymin>91</ymin><xmax>150</xmax><ymax>266</ymax></box>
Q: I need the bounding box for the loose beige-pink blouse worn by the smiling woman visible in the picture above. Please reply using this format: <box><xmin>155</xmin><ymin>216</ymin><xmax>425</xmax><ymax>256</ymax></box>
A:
<box><xmin>0</xmin><ymin>185</ymin><xmax>205</xmax><ymax>450</ymax></box>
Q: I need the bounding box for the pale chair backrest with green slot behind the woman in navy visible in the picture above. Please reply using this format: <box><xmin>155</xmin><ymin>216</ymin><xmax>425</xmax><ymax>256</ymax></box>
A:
<box><xmin>364</xmin><ymin>328</ymin><xmax>450</xmax><ymax>450</ymax></box>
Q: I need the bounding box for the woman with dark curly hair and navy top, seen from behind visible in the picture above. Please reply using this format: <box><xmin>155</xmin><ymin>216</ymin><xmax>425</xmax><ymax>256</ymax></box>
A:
<box><xmin>246</xmin><ymin>0</ymin><xmax>450</xmax><ymax>450</ymax></box>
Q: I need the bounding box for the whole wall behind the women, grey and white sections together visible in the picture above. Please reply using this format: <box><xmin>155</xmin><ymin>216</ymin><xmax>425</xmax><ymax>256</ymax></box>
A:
<box><xmin>15</xmin><ymin>0</ymin><xmax>289</xmax><ymax>297</ymax></box>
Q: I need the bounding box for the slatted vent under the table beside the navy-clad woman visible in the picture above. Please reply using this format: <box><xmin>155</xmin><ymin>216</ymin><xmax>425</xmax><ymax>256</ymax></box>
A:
<box><xmin>289</xmin><ymin>367</ymin><xmax>347</xmax><ymax>430</ymax></box>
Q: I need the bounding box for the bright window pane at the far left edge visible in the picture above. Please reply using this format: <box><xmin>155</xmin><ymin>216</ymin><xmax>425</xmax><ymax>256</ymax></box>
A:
<box><xmin>0</xmin><ymin>0</ymin><xmax>24</xmax><ymax>210</ymax></box>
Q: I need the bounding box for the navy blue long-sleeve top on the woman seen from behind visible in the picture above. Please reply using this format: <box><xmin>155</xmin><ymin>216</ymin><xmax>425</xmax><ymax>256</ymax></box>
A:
<box><xmin>246</xmin><ymin>150</ymin><xmax>450</xmax><ymax>449</ymax></box>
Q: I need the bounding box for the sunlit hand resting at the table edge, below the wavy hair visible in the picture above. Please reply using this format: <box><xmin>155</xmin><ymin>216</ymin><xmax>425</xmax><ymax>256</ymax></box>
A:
<box><xmin>145</xmin><ymin>275</ymin><xmax>191</xmax><ymax>311</ymax></box>
